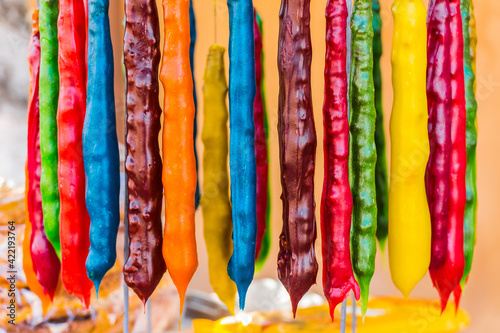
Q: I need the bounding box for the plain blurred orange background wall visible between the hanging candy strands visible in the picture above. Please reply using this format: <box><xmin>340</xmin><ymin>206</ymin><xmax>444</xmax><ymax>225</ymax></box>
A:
<box><xmin>25</xmin><ymin>0</ymin><xmax>500</xmax><ymax>332</ymax></box>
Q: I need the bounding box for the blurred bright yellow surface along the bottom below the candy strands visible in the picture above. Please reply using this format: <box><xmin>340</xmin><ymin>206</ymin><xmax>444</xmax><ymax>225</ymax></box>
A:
<box><xmin>193</xmin><ymin>298</ymin><xmax>470</xmax><ymax>333</ymax></box>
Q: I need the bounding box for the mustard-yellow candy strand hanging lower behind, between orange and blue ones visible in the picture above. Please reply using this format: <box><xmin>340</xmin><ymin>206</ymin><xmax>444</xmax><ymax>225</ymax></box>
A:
<box><xmin>201</xmin><ymin>45</ymin><xmax>236</xmax><ymax>313</ymax></box>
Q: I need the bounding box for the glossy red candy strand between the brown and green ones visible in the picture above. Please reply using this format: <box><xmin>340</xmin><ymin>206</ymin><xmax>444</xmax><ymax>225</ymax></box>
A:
<box><xmin>321</xmin><ymin>0</ymin><xmax>359</xmax><ymax>321</ymax></box>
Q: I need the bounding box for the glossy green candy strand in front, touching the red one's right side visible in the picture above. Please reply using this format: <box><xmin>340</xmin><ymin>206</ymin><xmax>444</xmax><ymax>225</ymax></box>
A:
<box><xmin>349</xmin><ymin>0</ymin><xmax>377</xmax><ymax>316</ymax></box>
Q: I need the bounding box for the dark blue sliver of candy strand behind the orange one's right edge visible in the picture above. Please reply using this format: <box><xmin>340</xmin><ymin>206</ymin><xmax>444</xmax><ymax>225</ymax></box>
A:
<box><xmin>189</xmin><ymin>0</ymin><xmax>200</xmax><ymax>209</ymax></box>
